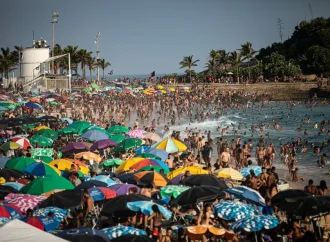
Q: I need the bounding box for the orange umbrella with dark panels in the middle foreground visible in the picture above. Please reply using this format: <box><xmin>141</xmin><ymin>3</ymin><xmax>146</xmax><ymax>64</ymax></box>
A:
<box><xmin>134</xmin><ymin>171</ymin><xmax>171</xmax><ymax>187</ymax></box>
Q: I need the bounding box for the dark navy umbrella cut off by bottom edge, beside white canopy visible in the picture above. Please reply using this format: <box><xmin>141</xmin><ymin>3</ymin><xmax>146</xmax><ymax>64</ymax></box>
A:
<box><xmin>54</xmin><ymin>228</ymin><xmax>110</xmax><ymax>242</ymax></box>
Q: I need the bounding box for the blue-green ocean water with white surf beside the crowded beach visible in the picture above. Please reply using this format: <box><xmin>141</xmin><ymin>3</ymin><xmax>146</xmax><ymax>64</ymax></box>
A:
<box><xmin>157</xmin><ymin>102</ymin><xmax>330</xmax><ymax>183</ymax></box>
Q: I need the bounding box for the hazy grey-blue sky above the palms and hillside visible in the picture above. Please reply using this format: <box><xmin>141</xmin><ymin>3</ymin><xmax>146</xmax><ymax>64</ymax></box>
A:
<box><xmin>0</xmin><ymin>0</ymin><xmax>330</xmax><ymax>75</ymax></box>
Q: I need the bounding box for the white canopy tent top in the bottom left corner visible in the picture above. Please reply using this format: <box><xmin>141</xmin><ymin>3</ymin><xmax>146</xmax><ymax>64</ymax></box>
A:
<box><xmin>0</xmin><ymin>219</ymin><xmax>67</xmax><ymax>242</ymax></box>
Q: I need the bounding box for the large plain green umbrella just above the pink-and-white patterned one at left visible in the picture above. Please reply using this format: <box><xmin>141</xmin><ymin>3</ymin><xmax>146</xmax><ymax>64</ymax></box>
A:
<box><xmin>20</xmin><ymin>176</ymin><xmax>74</xmax><ymax>195</ymax></box>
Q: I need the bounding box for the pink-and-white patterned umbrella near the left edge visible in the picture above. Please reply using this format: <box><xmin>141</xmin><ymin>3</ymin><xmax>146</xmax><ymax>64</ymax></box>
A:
<box><xmin>4</xmin><ymin>193</ymin><xmax>46</xmax><ymax>213</ymax></box>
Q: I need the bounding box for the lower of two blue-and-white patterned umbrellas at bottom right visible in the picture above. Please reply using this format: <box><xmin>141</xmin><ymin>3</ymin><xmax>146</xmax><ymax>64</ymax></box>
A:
<box><xmin>229</xmin><ymin>215</ymin><xmax>278</xmax><ymax>232</ymax></box>
